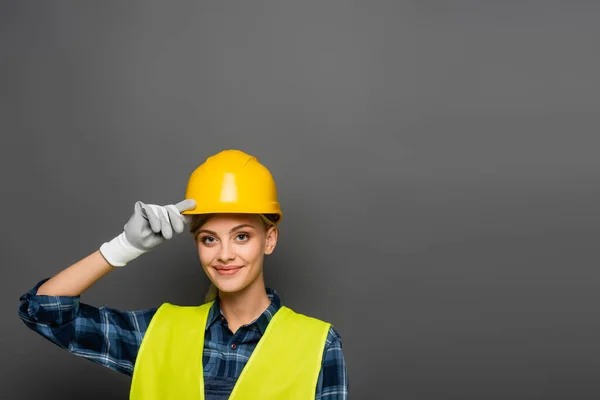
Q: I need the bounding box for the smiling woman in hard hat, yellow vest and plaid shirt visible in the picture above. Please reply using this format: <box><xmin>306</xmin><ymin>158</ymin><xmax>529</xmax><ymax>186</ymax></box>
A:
<box><xmin>19</xmin><ymin>150</ymin><xmax>348</xmax><ymax>400</ymax></box>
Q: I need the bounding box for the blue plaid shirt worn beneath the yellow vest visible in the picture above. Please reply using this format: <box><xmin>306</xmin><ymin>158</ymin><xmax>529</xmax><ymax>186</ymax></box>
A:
<box><xmin>19</xmin><ymin>278</ymin><xmax>348</xmax><ymax>400</ymax></box>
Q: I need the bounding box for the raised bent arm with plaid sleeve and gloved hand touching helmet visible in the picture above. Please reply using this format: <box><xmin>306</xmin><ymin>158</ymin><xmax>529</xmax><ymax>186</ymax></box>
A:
<box><xmin>19</xmin><ymin>200</ymin><xmax>195</xmax><ymax>374</ymax></box>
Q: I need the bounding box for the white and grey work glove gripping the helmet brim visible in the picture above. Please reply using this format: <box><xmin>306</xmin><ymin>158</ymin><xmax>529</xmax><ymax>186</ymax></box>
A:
<box><xmin>100</xmin><ymin>199</ymin><xmax>196</xmax><ymax>267</ymax></box>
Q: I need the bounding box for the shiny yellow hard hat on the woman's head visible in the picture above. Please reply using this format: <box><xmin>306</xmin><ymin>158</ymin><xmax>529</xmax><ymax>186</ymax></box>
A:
<box><xmin>182</xmin><ymin>150</ymin><xmax>283</xmax><ymax>222</ymax></box>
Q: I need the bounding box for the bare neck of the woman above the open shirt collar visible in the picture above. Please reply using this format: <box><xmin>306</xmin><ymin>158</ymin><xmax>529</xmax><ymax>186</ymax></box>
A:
<box><xmin>219</xmin><ymin>275</ymin><xmax>271</xmax><ymax>333</ymax></box>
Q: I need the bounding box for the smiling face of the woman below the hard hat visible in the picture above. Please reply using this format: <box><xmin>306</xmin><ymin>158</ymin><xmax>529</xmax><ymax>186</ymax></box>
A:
<box><xmin>196</xmin><ymin>214</ymin><xmax>277</xmax><ymax>293</ymax></box>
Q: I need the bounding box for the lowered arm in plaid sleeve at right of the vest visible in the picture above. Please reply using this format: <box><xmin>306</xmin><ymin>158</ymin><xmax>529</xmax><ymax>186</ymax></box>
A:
<box><xmin>315</xmin><ymin>327</ymin><xmax>349</xmax><ymax>400</ymax></box>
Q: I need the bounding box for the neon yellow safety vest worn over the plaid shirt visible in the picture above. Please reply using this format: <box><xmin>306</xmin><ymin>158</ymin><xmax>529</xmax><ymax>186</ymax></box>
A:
<box><xmin>130</xmin><ymin>302</ymin><xmax>331</xmax><ymax>400</ymax></box>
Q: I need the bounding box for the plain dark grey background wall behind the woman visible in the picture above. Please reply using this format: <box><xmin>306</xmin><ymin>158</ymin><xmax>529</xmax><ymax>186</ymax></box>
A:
<box><xmin>0</xmin><ymin>0</ymin><xmax>600</xmax><ymax>400</ymax></box>
